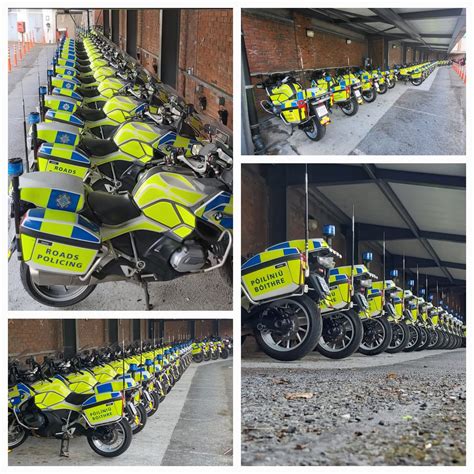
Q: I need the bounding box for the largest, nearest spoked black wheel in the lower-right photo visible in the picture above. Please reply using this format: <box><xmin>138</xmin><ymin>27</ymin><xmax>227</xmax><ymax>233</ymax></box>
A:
<box><xmin>254</xmin><ymin>295</ymin><xmax>322</xmax><ymax>361</ymax></box>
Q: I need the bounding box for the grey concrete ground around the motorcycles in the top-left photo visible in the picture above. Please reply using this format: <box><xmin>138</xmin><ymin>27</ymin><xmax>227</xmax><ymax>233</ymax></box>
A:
<box><xmin>8</xmin><ymin>45</ymin><xmax>232</xmax><ymax>311</ymax></box>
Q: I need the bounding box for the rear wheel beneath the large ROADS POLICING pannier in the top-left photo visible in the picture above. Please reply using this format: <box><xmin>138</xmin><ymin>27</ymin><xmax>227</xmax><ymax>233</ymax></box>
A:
<box><xmin>20</xmin><ymin>262</ymin><xmax>96</xmax><ymax>308</ymax></box>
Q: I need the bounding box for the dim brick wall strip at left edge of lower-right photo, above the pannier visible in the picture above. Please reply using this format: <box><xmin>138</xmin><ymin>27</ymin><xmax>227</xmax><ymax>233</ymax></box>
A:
<box><xmin>241</xmin><ymin>165</ymin><xmax>269</xmax><ymax>256</ymax></box>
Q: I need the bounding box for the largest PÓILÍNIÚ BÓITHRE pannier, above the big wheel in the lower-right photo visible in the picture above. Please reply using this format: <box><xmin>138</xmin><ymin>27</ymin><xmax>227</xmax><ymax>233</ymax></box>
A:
<box><xmin>242</xmin><ymin>247</ymin><xmax>304</xmax><ymax>301</ymax></box>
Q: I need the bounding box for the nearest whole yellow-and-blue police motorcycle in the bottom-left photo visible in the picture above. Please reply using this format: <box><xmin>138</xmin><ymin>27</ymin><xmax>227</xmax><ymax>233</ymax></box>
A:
<box><xmin>8</xmin><ymin>358</ymin><xmax>132</xmax><ymax>457</ymax></box>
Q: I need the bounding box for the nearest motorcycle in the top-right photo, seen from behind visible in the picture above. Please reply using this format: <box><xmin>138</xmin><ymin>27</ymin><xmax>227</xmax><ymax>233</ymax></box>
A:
<box><xmin>256</xmin><ymin>74</ymin><xmax>331</xmax><ymax>142</ymax></box>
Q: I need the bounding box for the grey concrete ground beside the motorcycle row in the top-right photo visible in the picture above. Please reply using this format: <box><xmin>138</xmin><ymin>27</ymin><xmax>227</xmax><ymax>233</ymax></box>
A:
<box><xmin>261</xmin><ymin>66</ymin><xmax>466</xmax><ymax>155</ymax></box>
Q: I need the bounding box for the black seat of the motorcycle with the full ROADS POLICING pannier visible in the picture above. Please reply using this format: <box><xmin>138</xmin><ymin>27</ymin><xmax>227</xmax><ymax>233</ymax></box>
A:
<box><xmin>87</xmin><ymin>191</ymin><xmax>141</xmax><ymax>225</ymax></box>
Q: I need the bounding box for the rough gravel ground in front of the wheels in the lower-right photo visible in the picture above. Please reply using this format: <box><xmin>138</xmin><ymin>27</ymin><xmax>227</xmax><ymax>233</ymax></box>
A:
<box><xmin>242</xmin><ymin>349</ymin><xmax>466</xmax><ymax>466</ymax></box>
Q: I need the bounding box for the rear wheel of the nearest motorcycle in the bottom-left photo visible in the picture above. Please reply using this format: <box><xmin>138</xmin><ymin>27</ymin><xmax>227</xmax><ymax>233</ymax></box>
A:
<box><xmin>87</xmin><ymin>420</ymin><xmax>132</xmax><ymax>458</ymax></box>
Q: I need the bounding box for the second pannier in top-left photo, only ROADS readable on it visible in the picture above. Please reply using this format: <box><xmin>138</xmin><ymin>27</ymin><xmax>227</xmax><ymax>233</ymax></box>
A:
<box><xmin>38</xmin><ymin>143</ymin><xmax>91</xmax><ymax>179</ymax></box>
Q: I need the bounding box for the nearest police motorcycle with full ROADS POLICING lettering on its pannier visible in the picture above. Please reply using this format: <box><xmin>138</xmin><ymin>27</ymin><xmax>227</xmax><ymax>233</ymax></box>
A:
<box><xmin>9</xmin><ymin>136</ymin><xmax>233</xmax><ymax>309</ymax></box>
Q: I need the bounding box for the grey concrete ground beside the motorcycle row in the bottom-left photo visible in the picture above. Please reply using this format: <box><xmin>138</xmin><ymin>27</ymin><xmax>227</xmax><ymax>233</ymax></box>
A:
<box><xmin>8</xmin><ymin>359</ymin><xmax>232</xmax><ymax>467</ymax></box>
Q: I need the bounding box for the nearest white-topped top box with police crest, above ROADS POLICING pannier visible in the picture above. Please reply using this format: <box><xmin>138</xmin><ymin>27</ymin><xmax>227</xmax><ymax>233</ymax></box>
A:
<box><xmin>19</xmin><ymin>171</ymin><xmax>84</xmax><ymax>212</ymax></box>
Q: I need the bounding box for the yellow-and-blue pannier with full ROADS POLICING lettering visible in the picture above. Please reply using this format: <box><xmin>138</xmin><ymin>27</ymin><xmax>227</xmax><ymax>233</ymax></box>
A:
<box><xmin>20</xmin><ymin>208</ymin><xmax>101</xmax><ymax>275</ymax></box>
